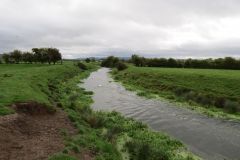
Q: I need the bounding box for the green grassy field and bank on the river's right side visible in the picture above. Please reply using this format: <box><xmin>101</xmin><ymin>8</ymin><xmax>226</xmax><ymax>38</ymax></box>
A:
<box><xmin>112</xmin><ymin>66</ymin><xmax>240</xmax><ymax>120</ymax></box>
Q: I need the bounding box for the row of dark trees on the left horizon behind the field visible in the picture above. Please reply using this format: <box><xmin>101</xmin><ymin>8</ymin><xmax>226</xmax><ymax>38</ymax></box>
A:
<box><xmin>2</xmin><ymin>48</ymin><xmax>62</xmax><ymax>64</ymax></box>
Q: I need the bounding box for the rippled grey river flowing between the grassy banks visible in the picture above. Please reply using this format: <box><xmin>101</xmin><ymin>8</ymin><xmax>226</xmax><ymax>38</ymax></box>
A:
<box><xmin>83</xmin><ymin>68</ymin><xmax>240</xmax><ymax>160</ymax></box>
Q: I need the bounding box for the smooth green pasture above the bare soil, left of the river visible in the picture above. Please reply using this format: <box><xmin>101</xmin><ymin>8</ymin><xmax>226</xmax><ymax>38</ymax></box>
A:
<box><xmin>0</xmin><ymin>62</ymin><xmax>84</xmax><ymax>115</ymax></box>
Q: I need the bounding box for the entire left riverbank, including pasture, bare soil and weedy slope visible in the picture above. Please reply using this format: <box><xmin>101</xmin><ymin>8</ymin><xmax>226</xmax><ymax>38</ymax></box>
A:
<box><xmin>0</xmin><ymin>62</ymin><xmax>197</xmax><ymax>160</ymax></box>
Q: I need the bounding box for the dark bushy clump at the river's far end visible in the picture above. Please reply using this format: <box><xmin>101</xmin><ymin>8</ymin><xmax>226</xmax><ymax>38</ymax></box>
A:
<box><xmin>101</xmin><ymin>56</ymin><xmax>128</xmax><ymax>71</ymax></box>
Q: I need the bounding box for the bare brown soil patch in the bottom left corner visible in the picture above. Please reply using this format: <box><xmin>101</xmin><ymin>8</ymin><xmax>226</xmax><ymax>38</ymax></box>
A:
<box><xmin>0</xmin><ymin>104</ymin><xmax>75</xmax><ymax>160</ymax></box>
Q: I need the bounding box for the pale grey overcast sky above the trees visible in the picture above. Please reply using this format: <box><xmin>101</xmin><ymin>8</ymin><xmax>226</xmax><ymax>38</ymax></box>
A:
<box><xmin>0</xmin><ymin>0</ymin><xmax>240</xmax><ymax>58</ymax></box>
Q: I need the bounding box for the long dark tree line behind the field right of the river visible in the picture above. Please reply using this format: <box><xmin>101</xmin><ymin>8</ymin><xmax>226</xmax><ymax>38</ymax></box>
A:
<box><xmin>129</xmin><ymin>55</ymin><xmax>240</xmax><ymax>70</ymax></box>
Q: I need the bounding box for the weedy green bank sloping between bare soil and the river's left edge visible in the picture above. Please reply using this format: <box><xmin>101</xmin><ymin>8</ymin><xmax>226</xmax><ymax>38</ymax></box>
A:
<box><xmin>50</xmin><ymin>65</ymin><xmax>197</xmax><ymax>160</ymax></box>
